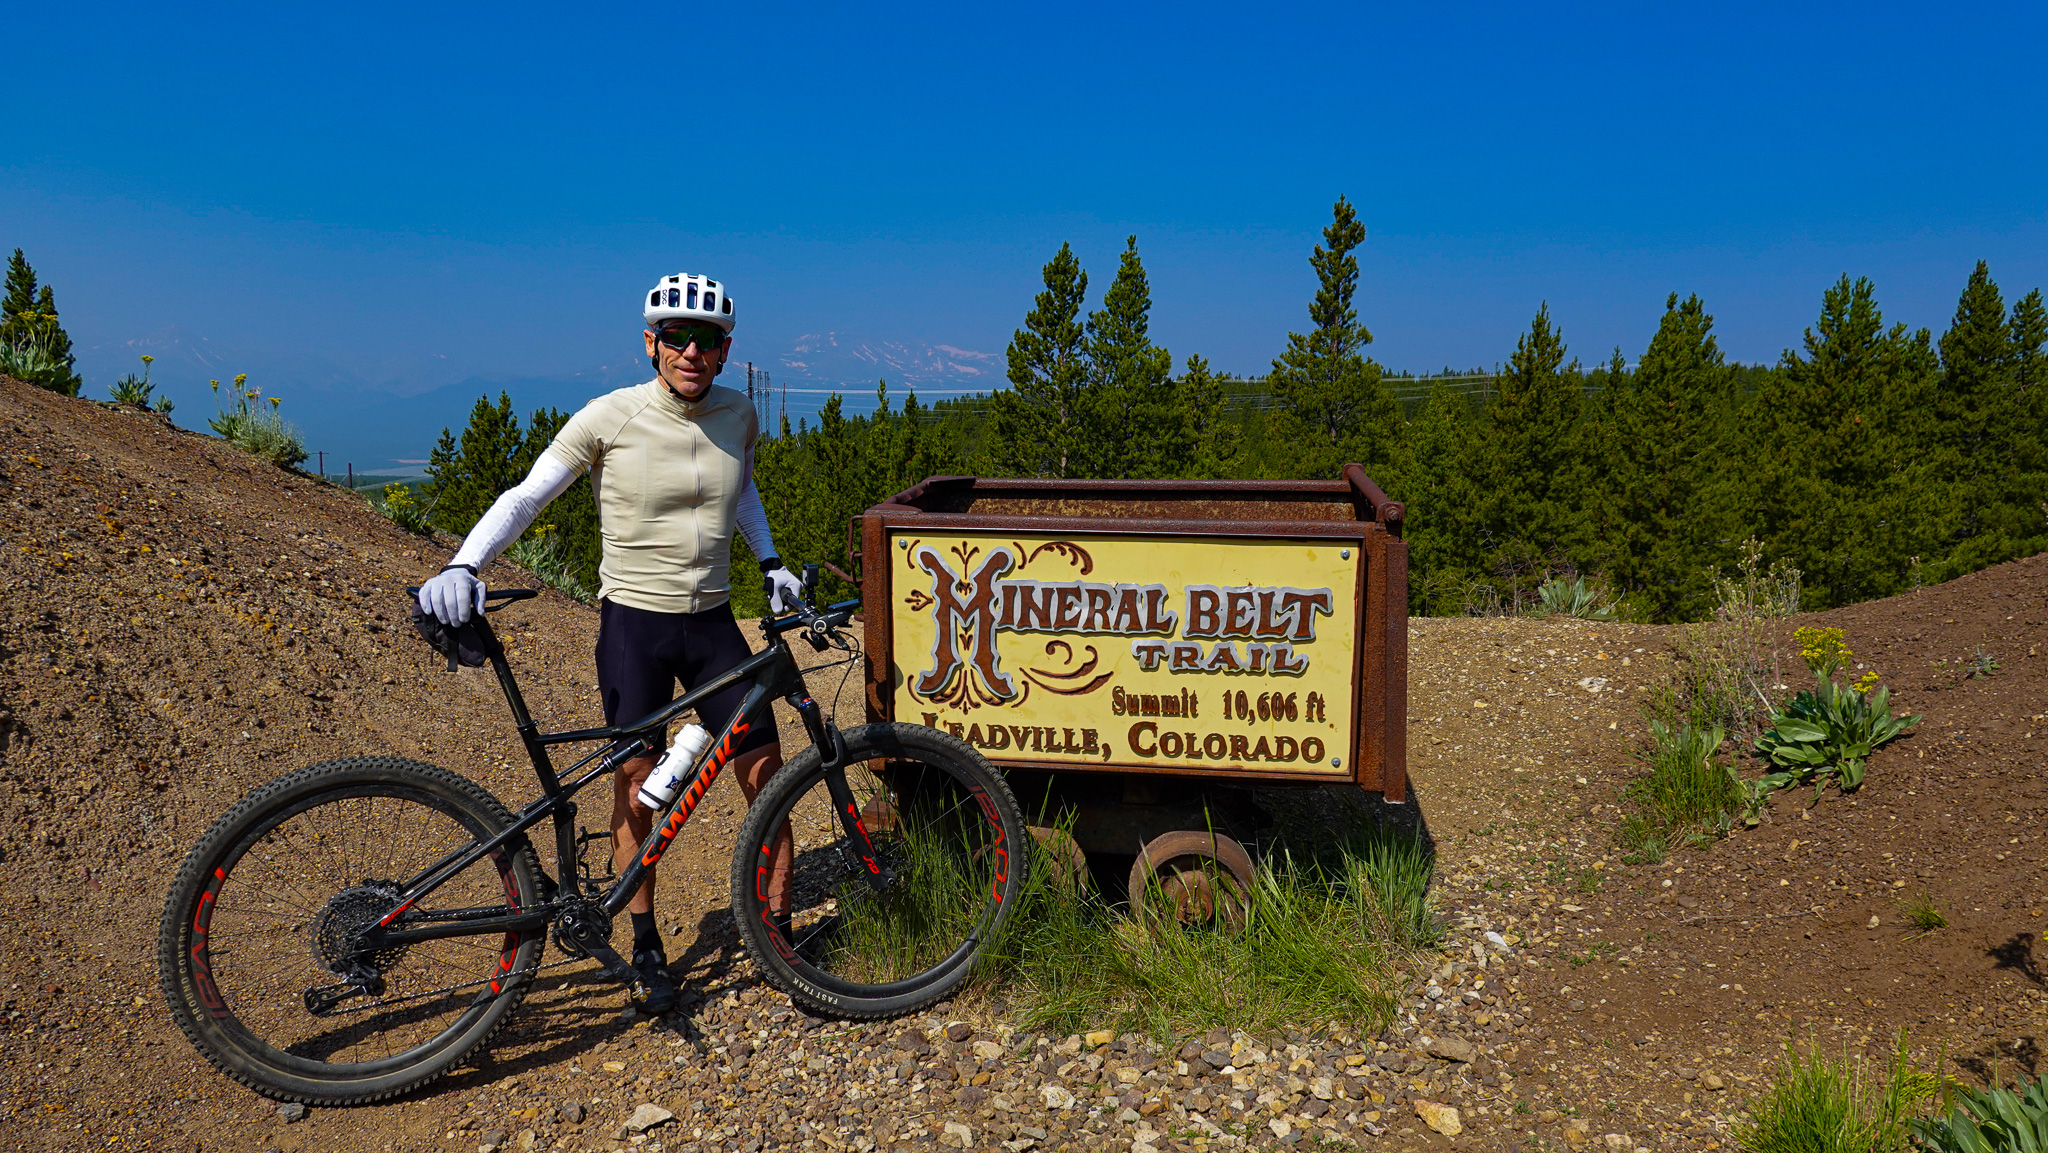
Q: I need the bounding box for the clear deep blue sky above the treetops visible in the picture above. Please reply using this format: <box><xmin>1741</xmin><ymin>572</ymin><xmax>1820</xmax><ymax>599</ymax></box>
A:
<box><xmin>0</xmin><ymin>4</ymin><xmax>2048</xmax><ymax>469</ymax></box>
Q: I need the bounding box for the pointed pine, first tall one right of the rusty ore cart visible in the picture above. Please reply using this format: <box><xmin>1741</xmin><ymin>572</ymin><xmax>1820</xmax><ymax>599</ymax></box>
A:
<box><xmin>1479</xmin><ymin>303</ymin><xmax>1589</xmax><ymax>569</ymax></box>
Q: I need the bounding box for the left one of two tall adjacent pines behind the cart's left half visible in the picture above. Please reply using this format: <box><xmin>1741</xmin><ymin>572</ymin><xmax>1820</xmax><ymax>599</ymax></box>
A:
<box><xmin>989</xmin><ymin>244</ymin><xmax>1087</xmax><ymax>477</ymax></box>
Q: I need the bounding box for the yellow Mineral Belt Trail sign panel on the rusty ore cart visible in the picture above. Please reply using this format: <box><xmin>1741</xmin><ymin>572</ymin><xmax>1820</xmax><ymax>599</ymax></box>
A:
<box><xmin>889</xmin><ymin>530</ymin><xmax>1364</xmax><ymax>776</ymax></box>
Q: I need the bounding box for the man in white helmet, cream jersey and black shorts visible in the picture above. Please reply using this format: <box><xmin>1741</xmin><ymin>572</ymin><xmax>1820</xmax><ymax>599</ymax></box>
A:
<box><xmin>420</xmin><ymin>272</ymin><xmax>803</xmax><ymax>1014</ymax></box>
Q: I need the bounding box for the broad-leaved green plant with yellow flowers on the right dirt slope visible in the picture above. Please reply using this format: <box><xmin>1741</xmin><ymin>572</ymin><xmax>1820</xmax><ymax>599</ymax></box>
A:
<box><xmin>1755</xmin><ymin>629</ymin><xmax>1919</xmax><ymax>793</ymax></box>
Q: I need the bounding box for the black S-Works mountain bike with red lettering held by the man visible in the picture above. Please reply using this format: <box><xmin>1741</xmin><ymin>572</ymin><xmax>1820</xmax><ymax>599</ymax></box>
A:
<box><xmin>158</xmin><ymin>565</ymin><xmax>1032</xmax><ymax>1106</ymax></box>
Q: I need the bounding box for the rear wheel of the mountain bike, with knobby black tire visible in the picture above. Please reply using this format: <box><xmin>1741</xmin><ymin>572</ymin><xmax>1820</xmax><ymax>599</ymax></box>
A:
<box><xmin>158</xmin><ymin>758</ymin><xmax>545</xmax><ymax>1104</ymax></box>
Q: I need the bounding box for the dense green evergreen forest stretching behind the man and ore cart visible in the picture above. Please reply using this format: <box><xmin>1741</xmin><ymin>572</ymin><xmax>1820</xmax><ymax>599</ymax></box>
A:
<box><xmin>426</xmin><ymin>199</ymin><xmax>2048</xmax><ymax>623</ymax></box>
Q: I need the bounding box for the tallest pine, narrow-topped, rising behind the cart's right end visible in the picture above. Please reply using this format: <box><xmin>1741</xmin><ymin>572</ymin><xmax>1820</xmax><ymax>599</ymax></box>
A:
<box><xmin>1268</xmin><ymin>197</ymin><xmax>1401</xmax><ymax>477</ymax></box>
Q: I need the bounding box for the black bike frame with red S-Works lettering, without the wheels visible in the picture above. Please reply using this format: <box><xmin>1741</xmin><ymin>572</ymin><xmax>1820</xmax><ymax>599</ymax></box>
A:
<box><xmin>358</xmin><ymin>590</ymin><xmax>887</xmax><ymax>952</ymax></box>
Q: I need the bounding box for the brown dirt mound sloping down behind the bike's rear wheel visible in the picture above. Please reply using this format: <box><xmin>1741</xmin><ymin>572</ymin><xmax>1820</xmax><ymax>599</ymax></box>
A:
<box><xmin>0</xmin><ymin>379</ymin><xmax>647</xmax><ymax>1147</ymax></box>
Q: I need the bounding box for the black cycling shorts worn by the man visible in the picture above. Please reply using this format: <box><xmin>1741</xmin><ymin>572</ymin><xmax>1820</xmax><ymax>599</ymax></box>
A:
<box><xmin>598</xmin><ymin>600</ymin><xmax>782</xmax><ymax>752</ymax></box>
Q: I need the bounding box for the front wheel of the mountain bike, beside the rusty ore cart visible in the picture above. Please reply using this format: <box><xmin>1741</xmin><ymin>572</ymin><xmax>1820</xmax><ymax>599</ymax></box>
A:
<box><xmin>731</xmin><ymin>723</ymin><xmax>1032</xmax><ymax>1018</ymax></box>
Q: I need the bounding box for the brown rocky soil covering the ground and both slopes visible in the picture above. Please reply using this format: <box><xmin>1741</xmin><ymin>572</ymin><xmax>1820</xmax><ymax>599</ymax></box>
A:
<box><xmin>0</xmin><ymin>381</ymin><xmax>2048</xmax><ymax>1153</ymax></box>
